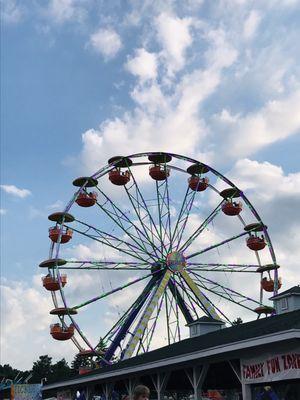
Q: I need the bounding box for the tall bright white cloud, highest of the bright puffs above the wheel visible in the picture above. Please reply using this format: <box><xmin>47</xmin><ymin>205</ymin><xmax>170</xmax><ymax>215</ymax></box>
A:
<box><xmin>155</xmin><ymin>13</ymin><xmax>193</xmax><ymax>75</ymax></box>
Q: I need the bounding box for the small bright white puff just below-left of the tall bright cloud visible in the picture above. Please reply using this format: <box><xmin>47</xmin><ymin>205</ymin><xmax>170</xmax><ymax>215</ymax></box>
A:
<box><xmin>125</xmin><ymin>48</ymin><xmax>157</xmax><ymax>81</ymax></box>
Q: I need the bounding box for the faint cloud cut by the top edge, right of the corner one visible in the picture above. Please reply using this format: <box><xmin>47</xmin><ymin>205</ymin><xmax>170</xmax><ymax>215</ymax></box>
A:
<box><xmin>47</xmin><ymin>0</ymin><xmax>86</xmax><ymax>24</ymax></box>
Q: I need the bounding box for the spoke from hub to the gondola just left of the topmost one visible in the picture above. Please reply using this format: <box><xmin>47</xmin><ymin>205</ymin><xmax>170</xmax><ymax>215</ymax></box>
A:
<box><xmin>126</xmin><ymin>171</ymin><xmax>160</xmax><ymax>250</ymax></box>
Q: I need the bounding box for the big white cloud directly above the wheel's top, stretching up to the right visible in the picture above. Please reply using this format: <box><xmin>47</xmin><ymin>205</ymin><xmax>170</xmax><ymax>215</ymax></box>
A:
<box><xmin>76</xmin><ymin>24</ymin><xmax>236</xmax><ymax>173</ymax></box>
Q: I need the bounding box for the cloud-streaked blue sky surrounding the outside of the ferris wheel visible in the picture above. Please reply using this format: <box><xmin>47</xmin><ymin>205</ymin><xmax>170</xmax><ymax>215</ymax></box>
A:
<box><xmin>1</xmin><ymin>0</ymin><xmax>300</xmax><ymax>368</ymax></box>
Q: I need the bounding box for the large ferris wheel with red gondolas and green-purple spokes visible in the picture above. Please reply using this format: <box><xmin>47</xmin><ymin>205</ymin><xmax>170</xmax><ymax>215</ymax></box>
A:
<box><xmin>40</xmin><ymin>152</ymin><xmax>281</xmax><ymax>364</ymax></box>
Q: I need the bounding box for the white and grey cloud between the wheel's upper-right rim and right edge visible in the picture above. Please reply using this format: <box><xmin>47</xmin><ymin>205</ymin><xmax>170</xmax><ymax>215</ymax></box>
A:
<box><xmin>227</xmin><ymin>159</ymin><xmax>300</xmax><ymax>290</ymax></box>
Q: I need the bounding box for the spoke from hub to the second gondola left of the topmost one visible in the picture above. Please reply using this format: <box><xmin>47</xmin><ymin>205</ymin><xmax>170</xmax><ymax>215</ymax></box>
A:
<box><xmin>97</xmin><ymin>187</ymin><xmax>161</xmax><ymax>256</ymax></box>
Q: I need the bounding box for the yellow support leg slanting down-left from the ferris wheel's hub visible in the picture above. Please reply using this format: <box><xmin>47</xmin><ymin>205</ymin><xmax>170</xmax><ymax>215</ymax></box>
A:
<box><xmin>123</xmin><ymin>270</ymin><xmax>172</xmax><ymax>359</ymax></box>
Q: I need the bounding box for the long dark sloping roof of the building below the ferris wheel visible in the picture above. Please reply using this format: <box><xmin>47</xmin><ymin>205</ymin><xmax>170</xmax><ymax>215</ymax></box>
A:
<box><xmin>44</xmin><ymin>310</ymin><xmax>300</xmax><ymax>390</ymax></box>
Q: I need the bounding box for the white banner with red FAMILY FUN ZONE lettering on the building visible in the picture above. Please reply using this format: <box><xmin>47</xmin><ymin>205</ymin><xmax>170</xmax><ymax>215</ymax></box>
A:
<box><xmin>241</xmin><ymin>349</ymin><xmax>300</xmax><ymax>383</ymax></box>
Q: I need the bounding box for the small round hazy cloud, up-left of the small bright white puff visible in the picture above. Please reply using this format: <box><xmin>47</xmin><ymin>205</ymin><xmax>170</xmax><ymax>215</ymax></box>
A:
<box><xmin>89</xmin><ymin>28</ymin><xmax>122</xmax><ymax>60</ymax></box>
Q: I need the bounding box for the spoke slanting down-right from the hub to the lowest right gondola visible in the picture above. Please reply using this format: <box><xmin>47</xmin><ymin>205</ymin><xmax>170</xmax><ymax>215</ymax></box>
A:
<box><xmin>192</xmin><ymin>272</ymin><xmax>260</xmax><ymax>311</ymax></box>
